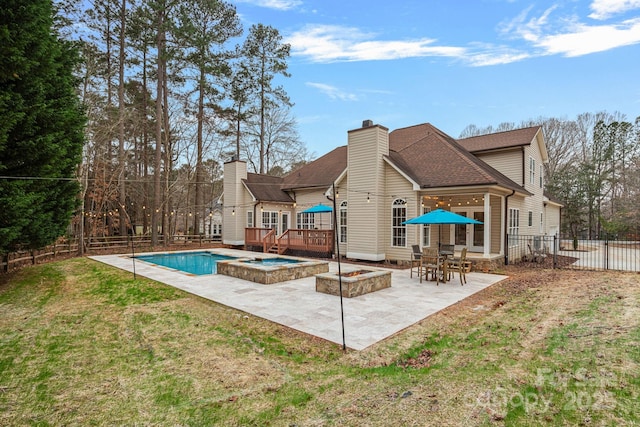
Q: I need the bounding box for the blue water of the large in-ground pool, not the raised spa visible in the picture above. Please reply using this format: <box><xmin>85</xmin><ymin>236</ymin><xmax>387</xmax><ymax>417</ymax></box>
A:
<box><xmin>135</xmin><ymin>252</ymin><xmax>237</xmax><ymax>276</ymax></box>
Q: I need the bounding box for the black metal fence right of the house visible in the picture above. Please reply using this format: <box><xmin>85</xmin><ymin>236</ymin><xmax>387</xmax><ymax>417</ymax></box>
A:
<box><xmin>508</xmin><ymin>235</ymin><xmax>640</xmax><ymax>272</ymax></box>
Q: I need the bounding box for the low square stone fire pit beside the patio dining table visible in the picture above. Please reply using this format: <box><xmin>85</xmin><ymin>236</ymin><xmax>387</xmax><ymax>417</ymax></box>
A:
<box><xmin>316</xmin><ymin>270</ymin><xmax>391</xmax><ymax>298</ymax></box>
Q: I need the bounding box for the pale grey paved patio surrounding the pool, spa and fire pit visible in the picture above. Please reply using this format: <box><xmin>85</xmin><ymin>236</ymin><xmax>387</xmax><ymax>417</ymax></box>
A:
<box><xmin>90</xmin><ymin>249</ymin><xmax>507</xmax><ymax>350</ymax></box>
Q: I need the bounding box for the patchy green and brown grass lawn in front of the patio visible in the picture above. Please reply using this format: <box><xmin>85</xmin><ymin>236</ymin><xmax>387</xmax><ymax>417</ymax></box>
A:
<box><xmin>0</xmin><ymin>258</ymin><xmax>640</xmax><ymax>426</ymax></box>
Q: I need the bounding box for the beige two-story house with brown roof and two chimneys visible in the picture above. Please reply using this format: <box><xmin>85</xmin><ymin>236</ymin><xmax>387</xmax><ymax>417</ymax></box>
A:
<box><xmin>223</xmin><ymin>120</ymin><xmax>560</xmax><ymax>266</ymax></box>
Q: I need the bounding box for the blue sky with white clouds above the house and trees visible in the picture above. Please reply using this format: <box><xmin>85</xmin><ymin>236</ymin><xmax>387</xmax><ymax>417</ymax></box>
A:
<box><xmin>233</xmin><ymin>0</ymin><xmax>640</xmax><ymax>157</ymax></box>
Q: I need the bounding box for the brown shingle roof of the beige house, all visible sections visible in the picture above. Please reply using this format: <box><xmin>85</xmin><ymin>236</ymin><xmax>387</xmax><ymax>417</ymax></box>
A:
<box><xmin>251</xmin><ymin>123</ymin><xmax>540</xmax><ymax>202</ymax></box>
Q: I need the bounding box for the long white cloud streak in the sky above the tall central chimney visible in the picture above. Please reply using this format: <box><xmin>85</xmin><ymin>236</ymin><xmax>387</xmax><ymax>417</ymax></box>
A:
<box><xmin>286</xmin><ymin>25</ymin><xmax>465</xmax><ymax>62</ymax></box>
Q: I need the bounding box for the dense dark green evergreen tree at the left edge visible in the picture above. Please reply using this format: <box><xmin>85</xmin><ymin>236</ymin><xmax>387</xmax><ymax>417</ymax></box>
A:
<box><xmin>0</xmin><ymin>0</ymin><xmax>85</xmax><ymax>253</ymax></box>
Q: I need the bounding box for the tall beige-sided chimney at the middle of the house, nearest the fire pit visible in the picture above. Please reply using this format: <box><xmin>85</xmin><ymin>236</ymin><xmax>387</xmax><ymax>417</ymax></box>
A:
<box><xmin>348</xmin><ymin>126</ymin><xmax>389</xmax><ymax>260</ymax></box>
